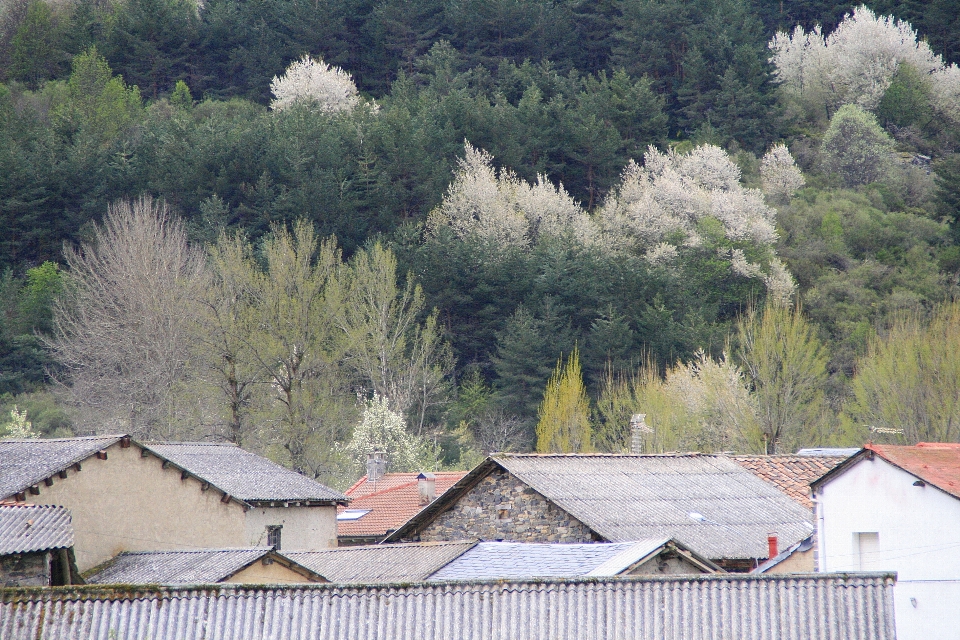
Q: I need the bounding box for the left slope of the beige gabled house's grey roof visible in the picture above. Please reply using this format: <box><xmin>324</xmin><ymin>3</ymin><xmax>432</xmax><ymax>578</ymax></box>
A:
<box><xmin>0</xmin><ymin>435</ymin><xmax>124</xmax><ymax>499</ymax></box>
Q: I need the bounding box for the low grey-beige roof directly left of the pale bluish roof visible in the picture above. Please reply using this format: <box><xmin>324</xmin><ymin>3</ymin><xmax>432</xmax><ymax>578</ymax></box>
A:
<box><xmin>285</xmin><ymin>542</ymin><xmax>476</xmax><ymax>584</ymax></box>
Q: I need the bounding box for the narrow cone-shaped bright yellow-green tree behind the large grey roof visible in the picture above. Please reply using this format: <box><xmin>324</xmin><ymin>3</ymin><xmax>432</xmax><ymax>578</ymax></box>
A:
<box><xmin>537</xmin><ymin>348</ymin><xmax>590</xmax><ymax>453</ymax></box>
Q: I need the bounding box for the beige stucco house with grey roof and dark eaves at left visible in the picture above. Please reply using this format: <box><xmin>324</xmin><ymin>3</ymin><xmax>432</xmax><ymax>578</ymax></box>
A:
<box><xmin>0</xmin><ymin>435</ymin><xmax>349</xmax><ymax>571</ymax></box>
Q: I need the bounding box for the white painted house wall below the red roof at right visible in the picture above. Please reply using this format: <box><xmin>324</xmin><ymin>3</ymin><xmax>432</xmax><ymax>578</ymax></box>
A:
<box><xmin>814</xmin><ymin>455</ymin><xmax>960</xmax><ymax>640</ymax></box>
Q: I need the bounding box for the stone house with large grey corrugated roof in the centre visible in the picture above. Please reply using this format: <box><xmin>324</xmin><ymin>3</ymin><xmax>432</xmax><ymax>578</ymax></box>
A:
<box><xmin>385</xmin><ymin>453</ymin><xmax>813</xmax><ymax>571</ymax></box>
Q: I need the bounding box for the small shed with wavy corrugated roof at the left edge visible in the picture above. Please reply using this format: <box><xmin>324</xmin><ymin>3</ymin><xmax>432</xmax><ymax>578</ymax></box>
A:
<box><xmin>0</xmin><ymin>503</ymin><xmax>83</xmax><ymax>587</ymax></box>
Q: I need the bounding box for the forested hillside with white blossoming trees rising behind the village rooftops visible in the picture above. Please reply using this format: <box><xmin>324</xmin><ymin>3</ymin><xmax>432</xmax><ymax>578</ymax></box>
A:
<box><xmin>0</xmin><ymin>0</ymin><xmax>960</xmax><ymax>485</ymax></box>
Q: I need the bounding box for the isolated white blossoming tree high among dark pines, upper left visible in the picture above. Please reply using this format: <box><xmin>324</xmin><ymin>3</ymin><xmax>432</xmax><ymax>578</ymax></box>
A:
<box><xmin>270</xmin><ymin>55</ymin><xmax>360</xmax><ymax>113</ymax></box>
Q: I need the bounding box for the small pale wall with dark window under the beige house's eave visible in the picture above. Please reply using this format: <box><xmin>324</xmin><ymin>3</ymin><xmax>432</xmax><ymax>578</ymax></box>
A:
<box><xmin>245</xmin><ymin>506</ymin><xmax>337</xmax><ymax>551</ymax></box>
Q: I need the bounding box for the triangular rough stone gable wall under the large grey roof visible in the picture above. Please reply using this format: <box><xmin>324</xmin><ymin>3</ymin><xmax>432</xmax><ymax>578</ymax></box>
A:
<box><xmin>419</xmin><ymin>468</ymin><xmax>600</xmax><ymax>543</ymax></box>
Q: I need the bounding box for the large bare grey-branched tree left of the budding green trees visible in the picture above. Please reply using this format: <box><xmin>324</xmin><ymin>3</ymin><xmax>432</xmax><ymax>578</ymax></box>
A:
<box><xmin>46</xmin><ymin>196</ymin><xmax>204</xmax><ymax>439</ymax></box>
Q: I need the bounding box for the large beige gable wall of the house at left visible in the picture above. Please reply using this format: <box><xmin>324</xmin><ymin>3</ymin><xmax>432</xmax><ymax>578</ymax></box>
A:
<box><xmin>27</xmin><ymin>443</ymin><xmax>246</xmax><ymax>571</ymax></box>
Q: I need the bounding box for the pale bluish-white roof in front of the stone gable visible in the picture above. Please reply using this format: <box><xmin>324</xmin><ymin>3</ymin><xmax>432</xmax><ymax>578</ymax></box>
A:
<box><xmin>430</xmin><ymin>538</ymin><xmax>652</xmax><ymax>581</ymax></box>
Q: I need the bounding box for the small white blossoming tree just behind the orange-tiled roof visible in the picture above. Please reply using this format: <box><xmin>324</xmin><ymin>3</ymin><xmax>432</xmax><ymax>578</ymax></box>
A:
<box><xmin>346</xmin><ymin>392</ymin><xmax>434</xmax><ymax>471</ymax></box>
